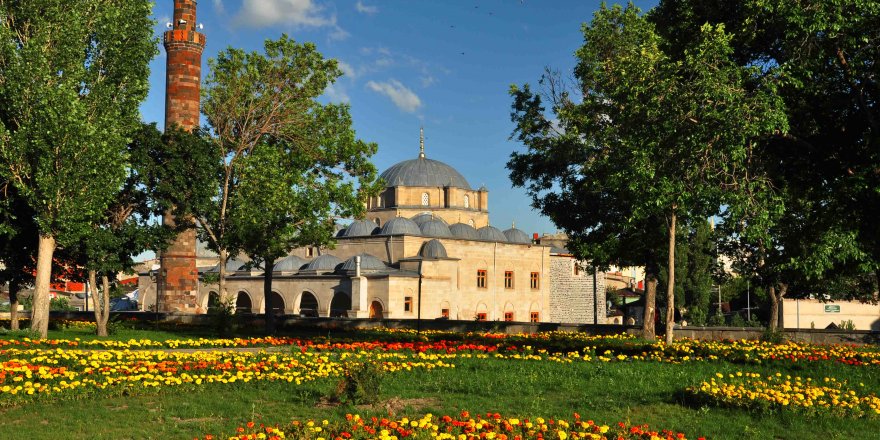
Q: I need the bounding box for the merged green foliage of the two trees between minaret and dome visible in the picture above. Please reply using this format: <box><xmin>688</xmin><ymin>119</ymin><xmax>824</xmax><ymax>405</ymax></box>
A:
<box><xmin>198</xmin><ymin>35</ymin><xmax>380</xmax><ymax>332</ymax></box>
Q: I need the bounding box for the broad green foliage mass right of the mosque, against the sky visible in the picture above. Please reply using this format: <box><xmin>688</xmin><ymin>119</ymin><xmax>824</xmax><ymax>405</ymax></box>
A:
<box><xmin>508</xmin><ymin>4</ymin><xmax>787</xmax><ymax>338</ymax></box>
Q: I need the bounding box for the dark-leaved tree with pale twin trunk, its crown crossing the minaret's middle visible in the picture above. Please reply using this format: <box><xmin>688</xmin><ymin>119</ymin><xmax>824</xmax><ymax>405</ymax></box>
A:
<box><xmin>68</xmin><ymin>124</ymin><xmax>201</xmax><ymax>336</ymax></box>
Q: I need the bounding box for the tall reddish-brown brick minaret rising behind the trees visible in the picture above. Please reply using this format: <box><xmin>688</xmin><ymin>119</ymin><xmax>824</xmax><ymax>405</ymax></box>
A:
<box><xmin>159</xmin><ymin>0</ymin><xmax>205</xmax><ymax>313</ymax></box>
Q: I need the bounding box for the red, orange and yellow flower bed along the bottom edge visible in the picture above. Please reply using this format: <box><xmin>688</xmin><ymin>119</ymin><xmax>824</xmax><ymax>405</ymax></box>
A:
<box><xmin>203</xmin><ymin>411</ymin><xmax>702</xmax><ymax>440</ymax></box>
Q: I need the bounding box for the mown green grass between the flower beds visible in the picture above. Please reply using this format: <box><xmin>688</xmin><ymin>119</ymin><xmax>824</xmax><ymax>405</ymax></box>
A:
<box><xmin>0</xmin><ymin>359</ymin><xmax>880</xmax><ymax>439</ymax></box>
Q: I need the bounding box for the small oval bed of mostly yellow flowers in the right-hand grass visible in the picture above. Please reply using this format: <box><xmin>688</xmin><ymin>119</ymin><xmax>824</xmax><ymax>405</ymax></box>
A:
<box><xmin>687</xmin><ymin>372</ymin><xmax>880</xmax><ymax>418</ymax></box>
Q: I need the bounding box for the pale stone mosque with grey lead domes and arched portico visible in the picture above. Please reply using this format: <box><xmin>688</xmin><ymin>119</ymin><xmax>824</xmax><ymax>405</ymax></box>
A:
<box><xmin>140</xmin><ymin>131</ymin><xmax>605</xmax><ymax>323</ymax></box>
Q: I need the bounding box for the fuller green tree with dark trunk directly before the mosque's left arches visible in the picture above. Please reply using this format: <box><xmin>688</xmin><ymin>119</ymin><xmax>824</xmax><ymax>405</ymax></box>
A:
<box><xmin>228</xmin><ymin>134</ymin><xmax>377</xmax><ymax>334</ymax></box>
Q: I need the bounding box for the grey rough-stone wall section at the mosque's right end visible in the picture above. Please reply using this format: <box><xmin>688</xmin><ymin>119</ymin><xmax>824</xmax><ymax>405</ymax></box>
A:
<box><xmin>549</xmin><ymin>255</ymin><xmax>606</xmax><ymax>324</ymax></box>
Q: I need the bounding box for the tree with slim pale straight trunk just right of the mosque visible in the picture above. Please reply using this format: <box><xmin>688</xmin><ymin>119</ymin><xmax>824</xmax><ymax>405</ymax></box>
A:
<box><xmin>513</xmin><ymin>5</ymin><xmax>784</xmax><ymax>342</ymax></box>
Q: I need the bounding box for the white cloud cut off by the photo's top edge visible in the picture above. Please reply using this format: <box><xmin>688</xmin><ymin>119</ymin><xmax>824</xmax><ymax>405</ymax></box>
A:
<box><xmin>235</xmin><ymin>0</ymin><xmax>336</xmax><ymax>27</ymax></box>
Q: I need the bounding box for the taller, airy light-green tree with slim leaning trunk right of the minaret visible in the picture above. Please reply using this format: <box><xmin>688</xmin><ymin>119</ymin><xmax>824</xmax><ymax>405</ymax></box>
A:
<box><xmin>195</xmin><ymin>35</ymin><xmax>375</xmax><ymax>316</ymax></box>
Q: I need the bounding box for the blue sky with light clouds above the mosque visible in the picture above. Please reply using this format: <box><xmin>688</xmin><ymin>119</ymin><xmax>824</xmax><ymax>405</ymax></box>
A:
<box><xmin>141</xmin><ymin>0</ymin><xmax>656</xmax><ymax>235</ymax></box>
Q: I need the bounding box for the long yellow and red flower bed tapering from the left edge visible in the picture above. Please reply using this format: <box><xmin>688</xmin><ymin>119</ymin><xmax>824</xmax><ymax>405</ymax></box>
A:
<box><xmin>0</xmin><ymin>349</ymin><xmax>454</xmax><ymax>405</ymax></box>
